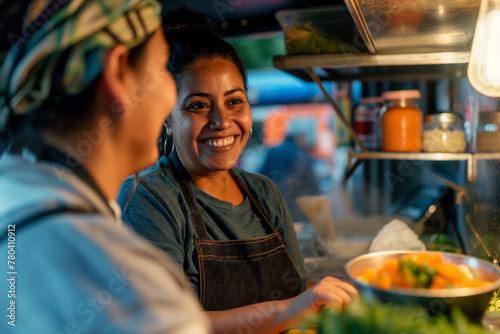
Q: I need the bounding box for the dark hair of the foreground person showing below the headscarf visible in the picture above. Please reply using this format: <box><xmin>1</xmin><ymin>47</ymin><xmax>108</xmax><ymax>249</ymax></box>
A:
<box><xmin>0</xmin><ymin>0</ymin><xmax>149</xmax><ymax>154</ymax></box>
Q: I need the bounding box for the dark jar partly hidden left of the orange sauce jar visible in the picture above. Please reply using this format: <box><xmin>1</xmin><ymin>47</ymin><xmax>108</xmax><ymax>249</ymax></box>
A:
<box><xmin>353</xmin><ymin>97</ymin><xmax>383</xmax><ymax>151</ymax></box>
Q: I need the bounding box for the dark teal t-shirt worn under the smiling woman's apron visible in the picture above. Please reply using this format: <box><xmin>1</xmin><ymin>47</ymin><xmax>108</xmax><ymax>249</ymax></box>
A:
<box><xmin>118</xmin><ymin>157</ymin><xmax>306</xmax><ymax>296</ymax></box>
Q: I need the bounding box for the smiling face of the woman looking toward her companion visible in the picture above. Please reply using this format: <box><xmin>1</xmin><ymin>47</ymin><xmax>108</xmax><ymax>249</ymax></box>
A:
<box><xmin>167</xmin><ymin>58</ymin><xmax>252</xmax><ymax>176</ymax></box>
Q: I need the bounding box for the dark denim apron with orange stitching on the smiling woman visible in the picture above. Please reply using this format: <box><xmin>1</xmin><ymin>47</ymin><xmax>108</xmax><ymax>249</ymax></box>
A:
<box><xmin>169</xmin><ymin>153</ymin><xmax>301</xmax><ymax>311</ymax></box>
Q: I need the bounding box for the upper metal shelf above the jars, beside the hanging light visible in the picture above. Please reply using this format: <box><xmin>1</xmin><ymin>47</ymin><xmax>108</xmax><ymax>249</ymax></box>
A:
<box><xmin>273</xmin><ymin>51</ymin><xmax>470</xmax><ymax>81</ymax></box>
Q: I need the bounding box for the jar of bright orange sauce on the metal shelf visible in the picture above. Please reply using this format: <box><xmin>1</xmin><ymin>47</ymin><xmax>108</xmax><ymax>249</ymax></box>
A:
<box><xmin>380</xmin><ymin>90</ymin><xmax>423</xmax><ymax>152</ymax></box>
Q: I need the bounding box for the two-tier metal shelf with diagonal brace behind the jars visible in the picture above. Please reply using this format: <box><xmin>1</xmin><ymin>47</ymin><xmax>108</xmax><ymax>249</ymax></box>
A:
<box><xmin>274</xmin><ymin>51</ymin><xmax>500</xmax><ymax>182</ymax></box>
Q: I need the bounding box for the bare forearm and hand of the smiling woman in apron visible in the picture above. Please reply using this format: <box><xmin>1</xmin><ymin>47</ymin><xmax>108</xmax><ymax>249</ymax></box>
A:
<box><xmin>206</xmin><ymin>277</ymin><xmax>358</xmax><ymax>334</ymax></box>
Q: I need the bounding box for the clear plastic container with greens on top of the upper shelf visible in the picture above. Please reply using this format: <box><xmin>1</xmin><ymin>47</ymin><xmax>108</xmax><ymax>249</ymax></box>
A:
<box><xmin>275</xmin><ymin>5</ymin><xmax>367</xmax><ymax>54</ymax></box>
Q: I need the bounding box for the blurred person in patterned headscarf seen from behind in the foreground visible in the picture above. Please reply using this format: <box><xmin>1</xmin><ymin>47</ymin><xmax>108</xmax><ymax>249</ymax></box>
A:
<box><xmin>0</xmin><ymin>0</ymin><xmax>211</xmax><ymax>334</ymax></box>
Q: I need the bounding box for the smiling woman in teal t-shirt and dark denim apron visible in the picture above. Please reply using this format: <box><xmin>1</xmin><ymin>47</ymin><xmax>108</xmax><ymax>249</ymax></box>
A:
<box><xmin>118</xmin><ymin>8</ymin><xmax>357</xmax><ymax>333</ymax></box>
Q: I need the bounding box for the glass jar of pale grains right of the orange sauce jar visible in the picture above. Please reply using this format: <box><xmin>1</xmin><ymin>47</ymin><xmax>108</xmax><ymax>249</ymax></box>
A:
<box><xmin>422</xmin><ymin>112</ymin><xmax>467</xmax><ymax>153</ymax></box>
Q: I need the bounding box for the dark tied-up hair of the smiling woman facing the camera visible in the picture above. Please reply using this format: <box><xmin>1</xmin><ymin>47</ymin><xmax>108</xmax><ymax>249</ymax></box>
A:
<box><xmin>163</xmin><ymin>6</ymin><xmax>247</xmax><ymax>90</ymax></box>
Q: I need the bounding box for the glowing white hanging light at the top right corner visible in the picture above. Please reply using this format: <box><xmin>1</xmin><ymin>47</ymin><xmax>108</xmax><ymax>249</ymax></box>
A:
<box><xmin>467</xmin><ymin>0</ymin><xmax>500</xmax><ymax>97</ymax></box>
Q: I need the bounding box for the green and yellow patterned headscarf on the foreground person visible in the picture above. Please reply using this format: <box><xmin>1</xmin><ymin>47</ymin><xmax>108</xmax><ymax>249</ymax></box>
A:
<box><xmin>0</xmin><ymin>0</ymin><xmax>161</xmax><ymax>130</ymax></box>
